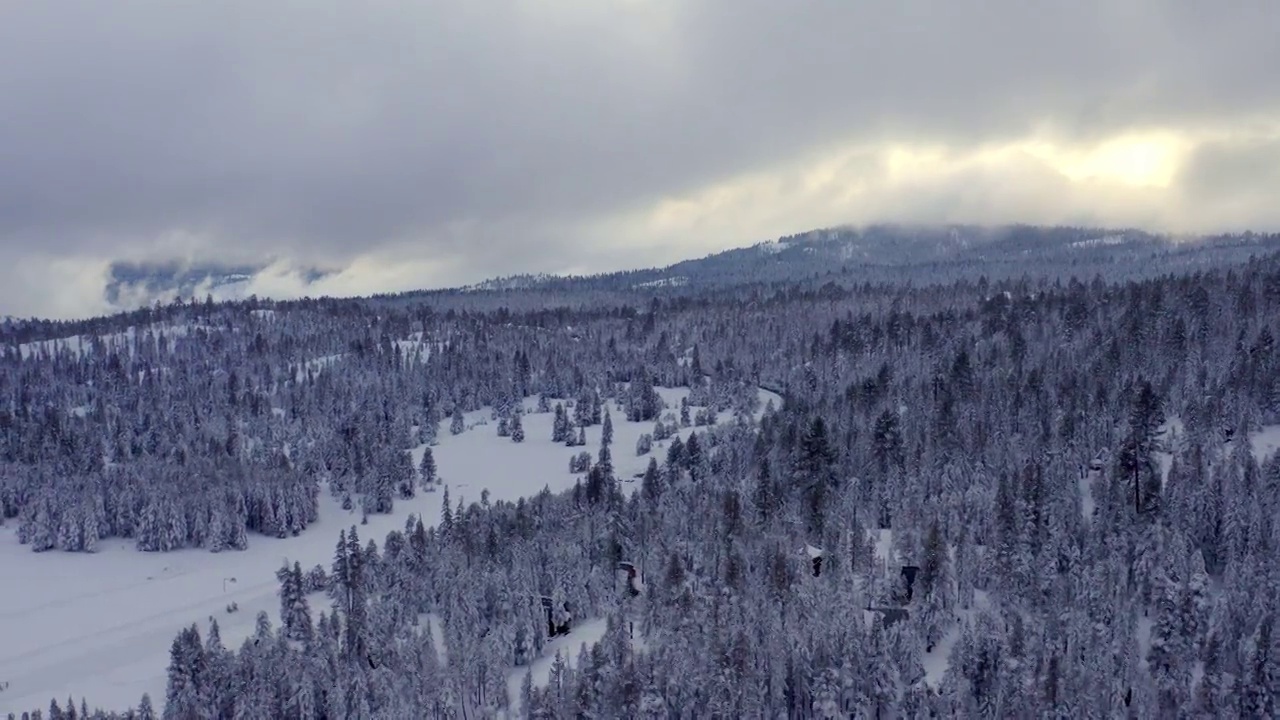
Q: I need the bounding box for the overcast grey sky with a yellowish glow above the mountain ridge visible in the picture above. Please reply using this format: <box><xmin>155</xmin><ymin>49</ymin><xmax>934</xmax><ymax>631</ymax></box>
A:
<box><xmin>0</xmin><ymin>0</ymin><xmax>1280</xmax><ymax>316</ymax></box>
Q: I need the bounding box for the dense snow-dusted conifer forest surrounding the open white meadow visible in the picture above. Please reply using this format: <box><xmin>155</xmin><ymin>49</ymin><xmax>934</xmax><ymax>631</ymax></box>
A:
<box><xmin>0</xmin><ymin>238</ymin><xmax>1280</xmax><ymax>719</ymax></box>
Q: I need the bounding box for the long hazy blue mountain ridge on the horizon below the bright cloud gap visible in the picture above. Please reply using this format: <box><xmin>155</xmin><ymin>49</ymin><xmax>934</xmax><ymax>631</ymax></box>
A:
<box><xmin>419</xmin><ymin>224</ymin><xmax>1280</xmax><ymax>297</ymax></box>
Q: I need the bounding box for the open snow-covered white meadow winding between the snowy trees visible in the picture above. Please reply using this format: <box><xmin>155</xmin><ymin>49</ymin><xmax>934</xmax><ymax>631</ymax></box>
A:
<box><xmin>0</xmin><ymin>389</ymin><xmax>781</xmax><ymax>716</ymax></box>
